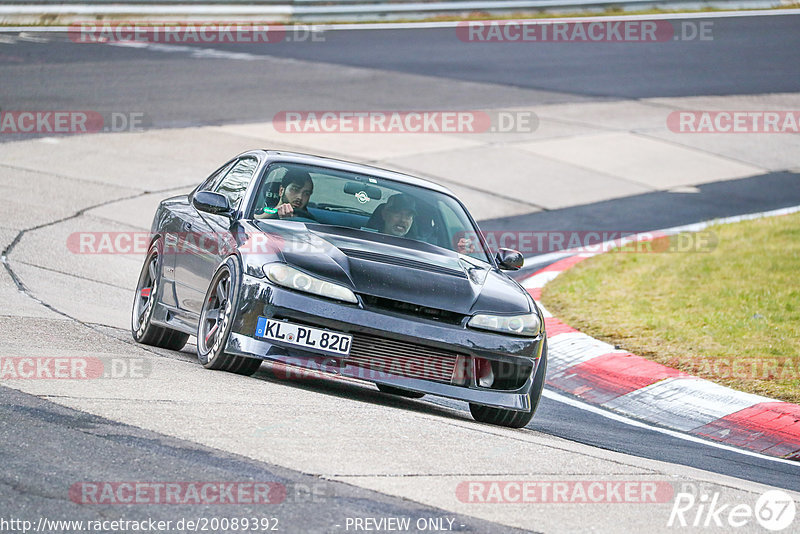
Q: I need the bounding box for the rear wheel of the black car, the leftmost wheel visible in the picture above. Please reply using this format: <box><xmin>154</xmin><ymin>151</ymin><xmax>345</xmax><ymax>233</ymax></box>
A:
<box><xmin>131</xmin><ymin>241</ymin><xmax>189</xmax><ymax>350</ymax></box>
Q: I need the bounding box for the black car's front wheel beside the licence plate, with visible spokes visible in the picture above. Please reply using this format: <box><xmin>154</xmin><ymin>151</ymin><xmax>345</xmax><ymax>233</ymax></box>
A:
<box><xmin>197</xmin><ymin>257</ymin><xmax>261</xmax><ymax>376</ymax></box>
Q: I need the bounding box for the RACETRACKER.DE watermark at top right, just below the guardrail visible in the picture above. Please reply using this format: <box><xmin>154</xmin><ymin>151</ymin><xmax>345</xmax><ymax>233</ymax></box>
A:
<box><xmin>456</xmin><ymin>19</ymin><xmax>714</xmax><ymax>43</ymax></box>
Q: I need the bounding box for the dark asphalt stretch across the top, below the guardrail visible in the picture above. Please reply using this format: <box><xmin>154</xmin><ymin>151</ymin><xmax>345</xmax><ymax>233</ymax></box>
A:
<box><xmin>0</xmin><ymin>15</ymin><xmax>800</xmax><ymax>128</ymax></box>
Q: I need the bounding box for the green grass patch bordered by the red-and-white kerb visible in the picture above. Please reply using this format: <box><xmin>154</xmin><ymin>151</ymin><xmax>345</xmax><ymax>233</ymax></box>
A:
<box><xmin>542</xmin><ymin>213</ymin><xmax>800</xmax><ymax>403</ymax></box>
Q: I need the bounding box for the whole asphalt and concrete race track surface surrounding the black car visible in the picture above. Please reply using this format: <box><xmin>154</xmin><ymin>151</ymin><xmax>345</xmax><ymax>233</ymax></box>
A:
<box><xmin>0</xmin><ymin>15</ymin><xmax>800</xmax><ymax>532</ymax></box>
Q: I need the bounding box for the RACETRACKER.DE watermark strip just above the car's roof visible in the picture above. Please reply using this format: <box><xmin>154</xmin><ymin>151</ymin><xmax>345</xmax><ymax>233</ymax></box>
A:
<box><xmin>272</xmin><ymin>110</ymin><xmax>539</xmax><ymax>134</ymax></box>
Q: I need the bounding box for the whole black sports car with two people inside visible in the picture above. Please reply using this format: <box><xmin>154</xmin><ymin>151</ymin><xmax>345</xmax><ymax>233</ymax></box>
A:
<box><xmin>132</xmin><ymin>150</ymin><xmax>547</xmax><ymax>427</ymax></box>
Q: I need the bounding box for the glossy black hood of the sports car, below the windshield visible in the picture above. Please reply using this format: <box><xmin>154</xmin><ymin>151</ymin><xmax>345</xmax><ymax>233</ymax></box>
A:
<box><xmin>248</xmin><ymin>221</ymin><xmax>531</xmax><ymax>315</ymax></box>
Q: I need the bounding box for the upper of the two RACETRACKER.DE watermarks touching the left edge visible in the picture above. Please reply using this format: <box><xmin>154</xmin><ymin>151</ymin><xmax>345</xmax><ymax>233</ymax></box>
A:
<box><xmin>0</xmin><ymin>110</ymin><xmax>145</xmax><ymax>135</ymax></box>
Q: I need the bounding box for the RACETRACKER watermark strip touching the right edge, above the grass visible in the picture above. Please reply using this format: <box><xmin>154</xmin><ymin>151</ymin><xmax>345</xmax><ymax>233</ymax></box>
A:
<box><xmin>667</xmin><ymin>110</ymin><xmax>800</xmax><ymax>134</ymax></box>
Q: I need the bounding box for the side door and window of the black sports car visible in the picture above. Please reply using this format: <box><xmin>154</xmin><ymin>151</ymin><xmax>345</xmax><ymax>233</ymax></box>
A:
<box><xmin>175</xmin><ymin>156</ymin><xmax>258</xmax><ymax>314</ymax></box>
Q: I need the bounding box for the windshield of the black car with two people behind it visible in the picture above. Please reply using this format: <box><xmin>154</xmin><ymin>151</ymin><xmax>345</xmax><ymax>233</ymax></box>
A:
<box><xmin>248</xmin><ymin>163</ymin><xmax>489</xmax><ymax>262</ymax></box>
